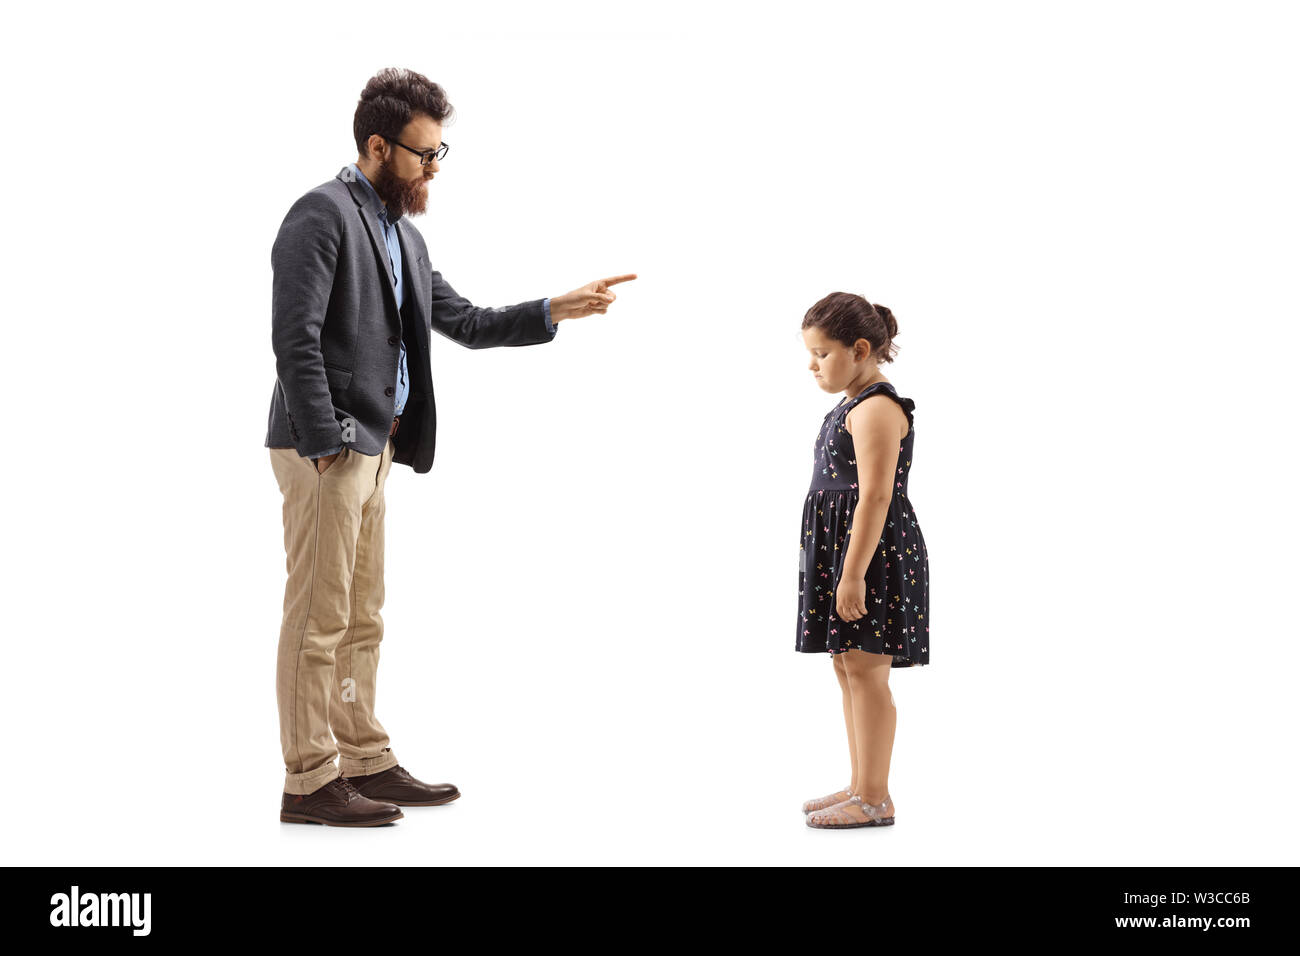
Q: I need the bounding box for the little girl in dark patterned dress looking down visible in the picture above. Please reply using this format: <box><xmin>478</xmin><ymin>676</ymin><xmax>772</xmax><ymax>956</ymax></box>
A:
<box><xmin>794</xmin><ymin>293</ymin><xmax>930</xmax><ymax>830</ymax></box>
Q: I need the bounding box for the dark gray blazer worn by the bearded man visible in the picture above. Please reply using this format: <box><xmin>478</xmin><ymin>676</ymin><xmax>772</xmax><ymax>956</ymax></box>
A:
<box><xmin>265</xmin><ymin>166</ymin><xmax>555</xmax><ymax>473</ymax></box>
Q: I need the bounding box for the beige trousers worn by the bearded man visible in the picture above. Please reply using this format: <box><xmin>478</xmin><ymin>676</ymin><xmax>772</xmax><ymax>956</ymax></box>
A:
<box><xmin>270</xmin><ymin>438</ymin><xmax>398</xmax><ymax>793</ymax></box>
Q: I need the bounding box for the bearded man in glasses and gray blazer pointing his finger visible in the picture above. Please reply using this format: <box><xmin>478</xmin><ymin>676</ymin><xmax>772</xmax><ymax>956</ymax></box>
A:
<box><xmin>265</xmin><ymin>69</ymin><xmax>636</xmax><ymax>826</ymax></box>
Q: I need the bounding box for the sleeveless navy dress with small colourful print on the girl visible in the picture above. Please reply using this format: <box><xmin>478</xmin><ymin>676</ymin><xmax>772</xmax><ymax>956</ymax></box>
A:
<box><xmin>794</xmin><ymin>382</ymin><xmax>930</xmax><ymax>667</ymax></box>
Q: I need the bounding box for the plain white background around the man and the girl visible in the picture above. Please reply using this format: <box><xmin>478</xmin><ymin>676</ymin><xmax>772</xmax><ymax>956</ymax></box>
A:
<box><xmin>0</xmin><ymin>3</ymin><xmax>1300</xmax><ymax>865</ymax></box>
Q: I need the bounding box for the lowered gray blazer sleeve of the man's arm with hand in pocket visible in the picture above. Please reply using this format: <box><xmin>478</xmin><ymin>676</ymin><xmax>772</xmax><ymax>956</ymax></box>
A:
<box><xmin>270</xmin><ymin>193</ymin><xmax>343</xmax><ymax>455</ymax></box>
